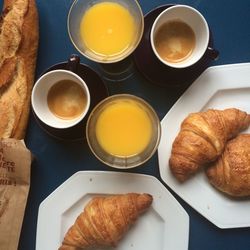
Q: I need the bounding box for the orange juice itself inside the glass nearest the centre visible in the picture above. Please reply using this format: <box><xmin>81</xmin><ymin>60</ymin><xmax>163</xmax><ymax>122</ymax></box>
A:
<box><xmin>96</xmin><ymin>100</ymin><xmax>153</xmax><ymax>157</ymax></box>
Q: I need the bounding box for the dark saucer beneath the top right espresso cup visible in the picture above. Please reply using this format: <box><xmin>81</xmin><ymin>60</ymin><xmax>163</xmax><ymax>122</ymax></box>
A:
<box><xmin>134</xmin><ymin>4</ymin><xmax>218</xmax><ymax>87</ymax></box>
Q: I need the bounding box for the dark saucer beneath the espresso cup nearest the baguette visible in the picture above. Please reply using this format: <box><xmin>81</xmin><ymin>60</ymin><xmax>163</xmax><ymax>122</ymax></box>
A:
<box><xmin>32</xmin><ymin>55</ymin><xmax>109</xmax><ymax>141</ymax></box>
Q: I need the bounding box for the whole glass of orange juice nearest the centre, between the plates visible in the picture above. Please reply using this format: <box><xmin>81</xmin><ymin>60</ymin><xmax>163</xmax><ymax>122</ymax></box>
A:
<box><xmin>86</xmin><ymin>94</ymin><xmax>161</xmax><ymax>169</ymax></box>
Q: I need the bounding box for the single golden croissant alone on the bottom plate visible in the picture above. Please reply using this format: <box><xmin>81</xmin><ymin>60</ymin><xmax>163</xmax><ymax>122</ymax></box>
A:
<box><xmin>59</xmin><ymin>193</ymin><xmax>153</xmax><ymax>250</ymax></box>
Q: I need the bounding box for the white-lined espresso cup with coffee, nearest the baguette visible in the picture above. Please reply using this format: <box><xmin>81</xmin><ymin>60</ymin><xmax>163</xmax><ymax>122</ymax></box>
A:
<box><xmin>31</xmin><ymin>69</ymin><xmax>90</xmax><ymax>129</ymax></box>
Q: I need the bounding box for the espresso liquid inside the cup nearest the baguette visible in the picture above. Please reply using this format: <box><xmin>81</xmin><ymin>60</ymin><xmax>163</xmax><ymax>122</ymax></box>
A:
<box><xmin>47</xmin><ymin>80</ymin><xmax>87</xmax><ymax>120</ymax></box>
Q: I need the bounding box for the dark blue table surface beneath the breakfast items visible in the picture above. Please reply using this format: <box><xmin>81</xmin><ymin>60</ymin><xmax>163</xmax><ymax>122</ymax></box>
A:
<box><xmin>0</xmin><ymin>0</ymin><xmax>250</xmax><ymax>250</ymax></box>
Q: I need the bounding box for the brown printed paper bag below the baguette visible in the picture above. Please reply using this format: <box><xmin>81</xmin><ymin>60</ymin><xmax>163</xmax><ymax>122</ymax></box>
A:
<box><xmin>0</xmin><ymin>139</ymin><xmax>31</xmax><ymax>250</ymax></box>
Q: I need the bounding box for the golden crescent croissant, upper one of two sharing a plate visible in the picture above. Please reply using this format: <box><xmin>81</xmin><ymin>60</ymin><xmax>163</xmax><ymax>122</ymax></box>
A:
<box><xmin>169</xmin><ymin>108</ymin><xmax>250</xmax><ymax>181</ymax></box>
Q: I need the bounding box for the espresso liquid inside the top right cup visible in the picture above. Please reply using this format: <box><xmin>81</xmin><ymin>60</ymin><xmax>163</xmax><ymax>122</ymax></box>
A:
<box><xmin>154</xmin><ymin>19</ymin><xmax>195</xmax><ymax>63</ymax></box>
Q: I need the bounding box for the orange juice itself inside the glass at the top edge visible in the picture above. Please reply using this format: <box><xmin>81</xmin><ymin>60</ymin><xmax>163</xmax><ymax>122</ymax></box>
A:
<box><xmin>80</xmin><ymin>2</ymin><xmax>135</xmax><ymax>56</ymax></box>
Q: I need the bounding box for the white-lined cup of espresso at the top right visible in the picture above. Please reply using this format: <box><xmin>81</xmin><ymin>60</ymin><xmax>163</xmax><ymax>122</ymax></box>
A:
<box><xmin>150</xmin><ymin>5</ymin><xmax>209</xmax><ymax>68</ymax></box>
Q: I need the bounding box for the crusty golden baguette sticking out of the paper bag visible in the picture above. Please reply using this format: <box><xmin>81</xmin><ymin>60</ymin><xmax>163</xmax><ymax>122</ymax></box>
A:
<box><xmin>0</xmin><ymin>0</ymin><xmax>39</xmax><ymax>139</ymax></box>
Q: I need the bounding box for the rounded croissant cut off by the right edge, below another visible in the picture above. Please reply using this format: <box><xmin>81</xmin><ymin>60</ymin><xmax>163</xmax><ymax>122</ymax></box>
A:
<box><xmin>206</xmin><ymin>134</ymin><xmax>250</xmax><ymax>197</ymax></box>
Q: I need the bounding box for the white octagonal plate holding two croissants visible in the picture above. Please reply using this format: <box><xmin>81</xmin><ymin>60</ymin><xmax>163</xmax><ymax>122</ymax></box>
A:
<box><xmin>158</xmin><ymin>63</ymin><xmax>250</xmax><ymax>228</ymax></box>
